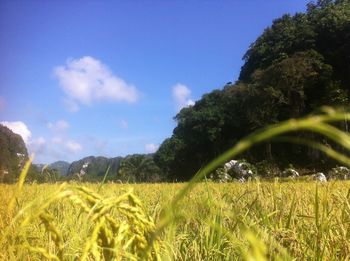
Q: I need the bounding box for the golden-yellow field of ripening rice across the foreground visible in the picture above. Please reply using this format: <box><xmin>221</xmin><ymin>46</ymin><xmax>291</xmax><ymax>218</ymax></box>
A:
<box><xmin>0</xmin><ymin>181</ymin><xmax>350</xmax><ymax>260</ymax></box>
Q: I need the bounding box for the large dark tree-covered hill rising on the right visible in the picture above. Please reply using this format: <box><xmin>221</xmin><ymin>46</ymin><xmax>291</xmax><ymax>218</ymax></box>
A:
<box><xmin>155</xmin><ymin>0</ymin><xmax>350</xmax><ymax>180</ymax></box>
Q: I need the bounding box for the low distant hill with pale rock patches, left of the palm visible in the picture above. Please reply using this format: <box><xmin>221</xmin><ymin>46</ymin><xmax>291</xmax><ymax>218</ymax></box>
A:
<box><xmin>67</xmin><ymin>156</ymin><xmax>123</xmax><ymax>180</ymax></box>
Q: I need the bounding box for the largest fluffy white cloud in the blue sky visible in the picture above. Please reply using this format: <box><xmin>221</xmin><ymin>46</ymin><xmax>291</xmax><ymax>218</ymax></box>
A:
<box><xmin>54</xmin><ymin>56</ymin><xmax>139</xmax><ymax>111</ymax></box>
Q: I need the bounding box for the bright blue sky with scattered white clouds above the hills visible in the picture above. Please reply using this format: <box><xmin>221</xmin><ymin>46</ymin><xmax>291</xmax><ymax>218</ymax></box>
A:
<box><xmin>0</xmin><ymin>0</ymin><xmax>308</xmax><ymax>163</ymax></box>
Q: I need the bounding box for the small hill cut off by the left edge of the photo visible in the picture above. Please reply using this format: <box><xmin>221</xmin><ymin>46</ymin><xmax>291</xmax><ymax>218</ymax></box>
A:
<box><xmin>0</xmin><ymin>124</ymin><xmax>28</xmax><ymax>182</ymax></box>
